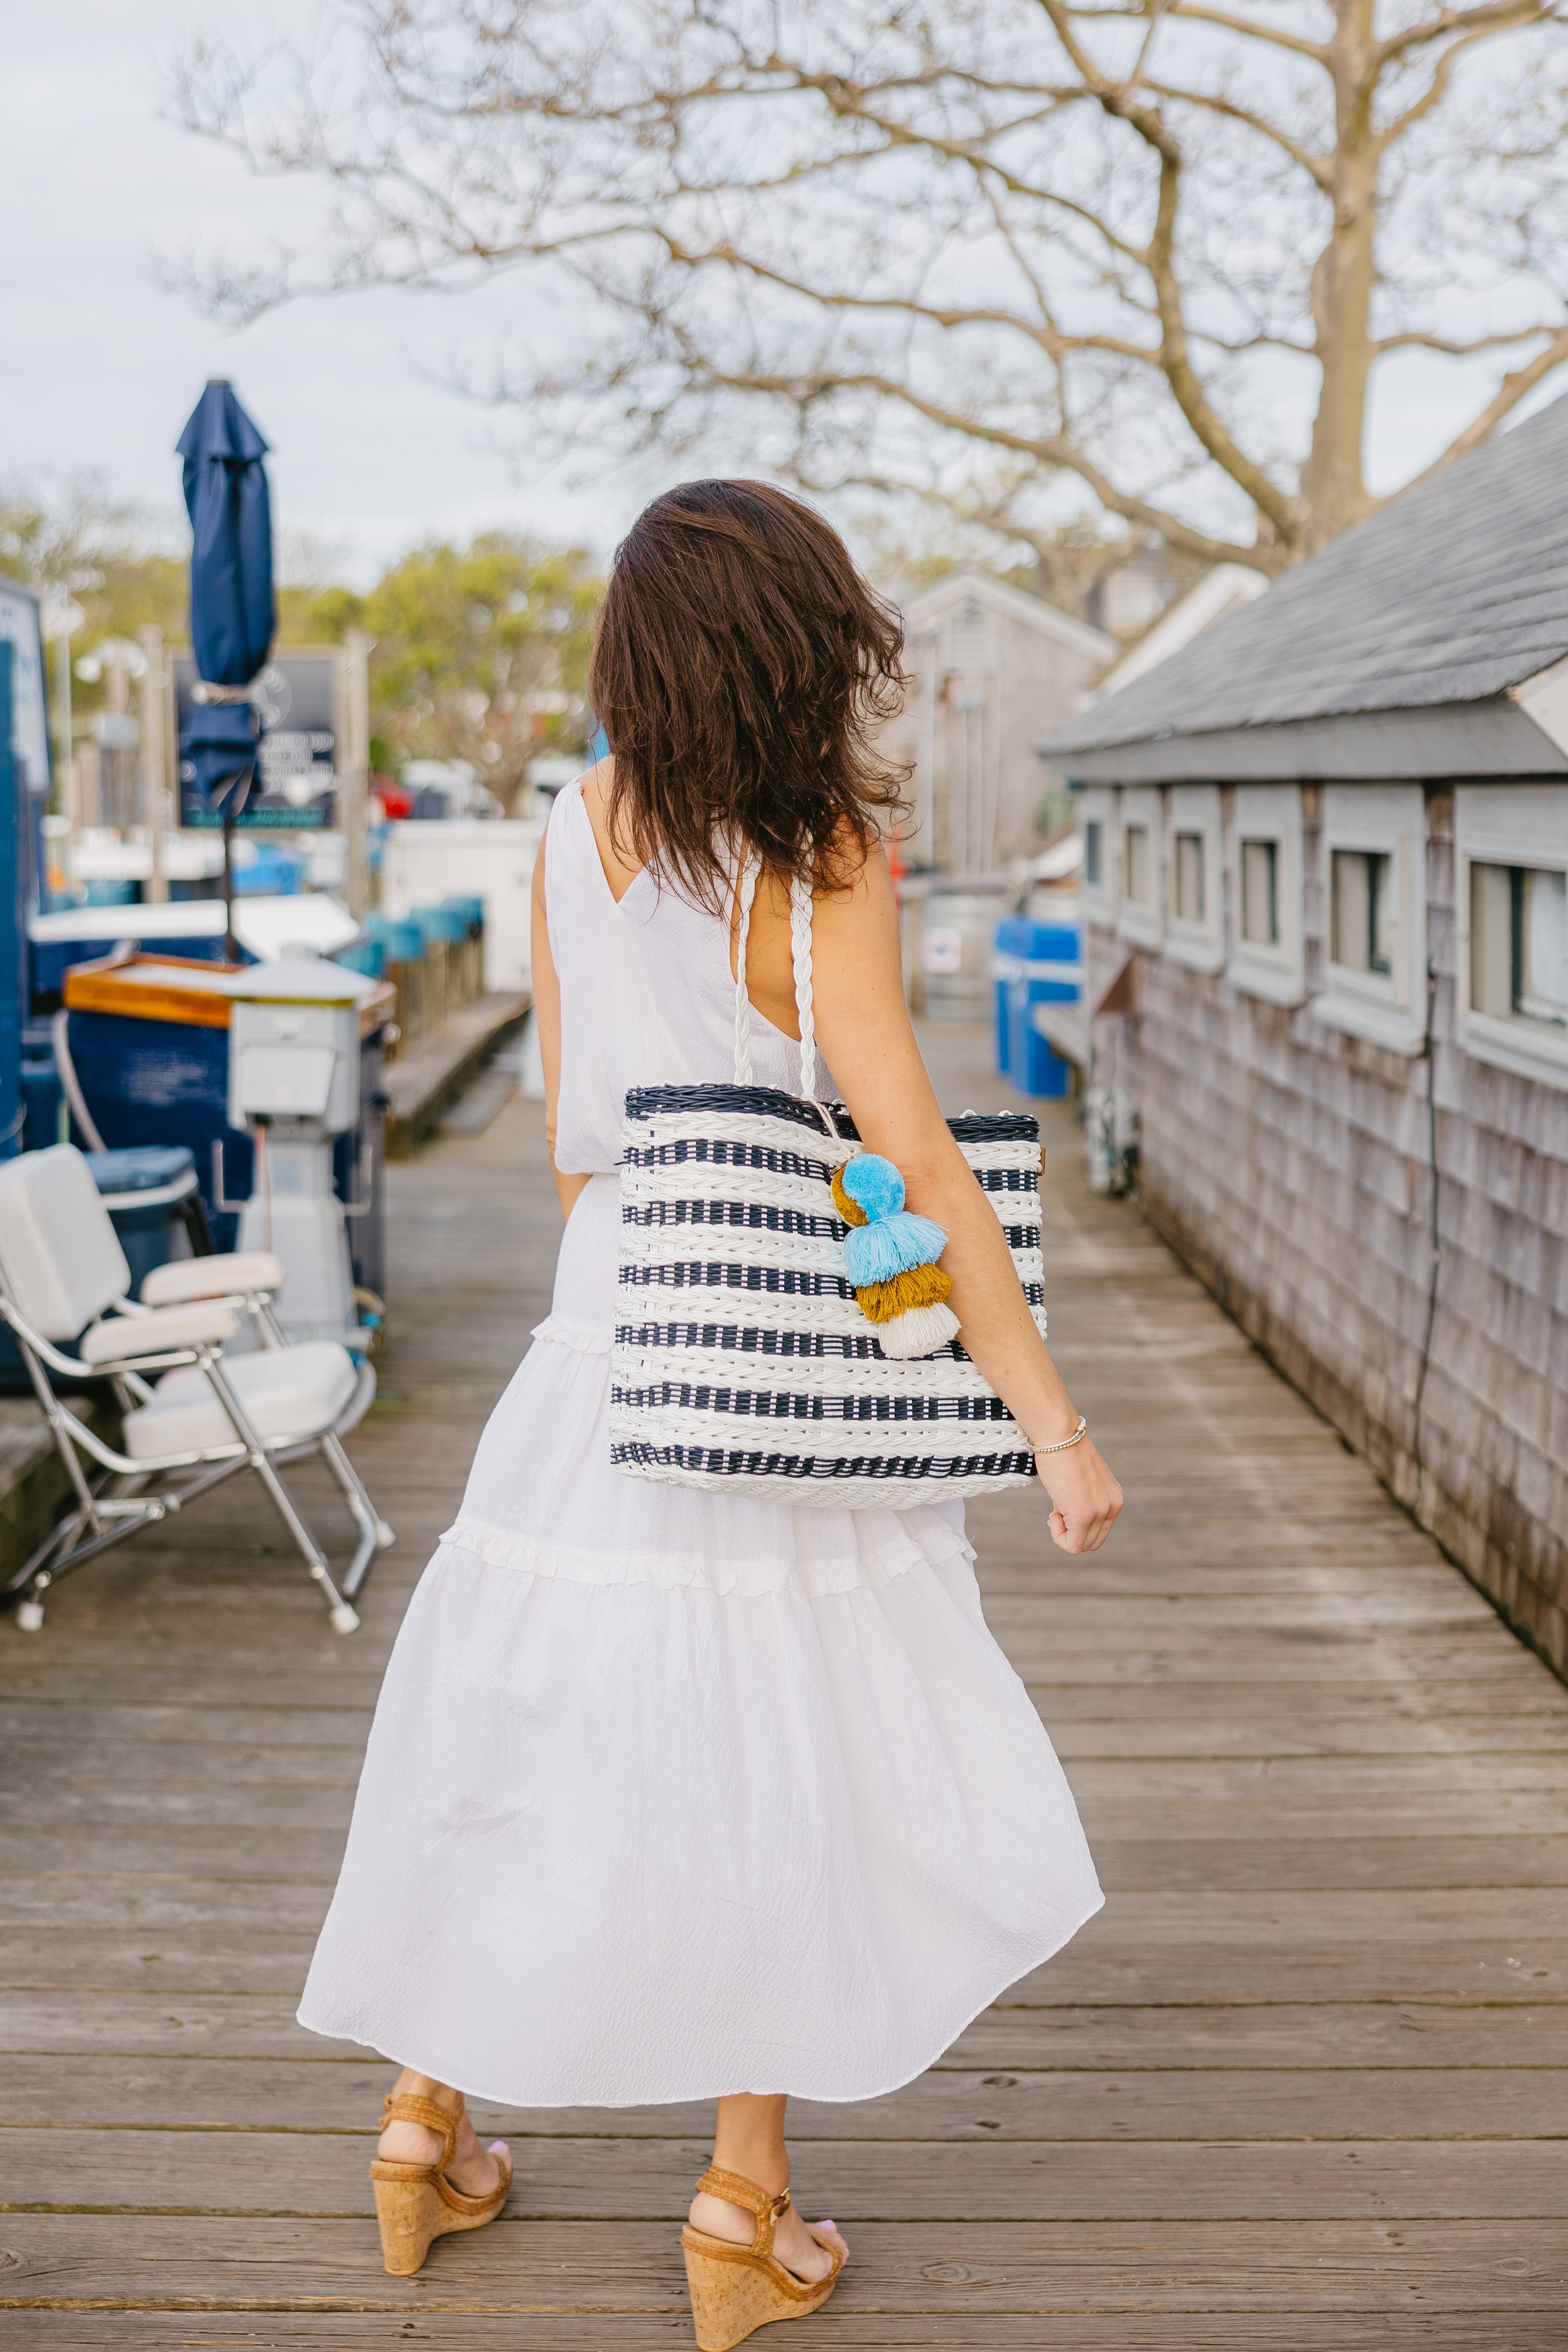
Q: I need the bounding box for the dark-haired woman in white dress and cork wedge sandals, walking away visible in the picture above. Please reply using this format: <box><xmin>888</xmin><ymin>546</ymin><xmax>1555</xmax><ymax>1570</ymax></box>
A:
<box><xmin>301</xmin><ymin>482</ymin><xmax>1121</xmax><ymax>2347</ymax></box>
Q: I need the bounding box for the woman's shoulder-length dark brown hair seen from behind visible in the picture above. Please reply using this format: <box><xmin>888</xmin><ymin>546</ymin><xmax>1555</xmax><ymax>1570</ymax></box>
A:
<box><xmin>590</xmin><ymin>482</ymin><xmax>907</xmax><ymax>910</ymax></box>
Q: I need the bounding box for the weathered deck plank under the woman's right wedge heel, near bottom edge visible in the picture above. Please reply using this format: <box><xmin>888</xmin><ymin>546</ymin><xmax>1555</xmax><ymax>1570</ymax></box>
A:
<box><xmin>5</xmin><ymin>2211</ymin><xmax>1568</xmax><ymax>2324</ymax></box>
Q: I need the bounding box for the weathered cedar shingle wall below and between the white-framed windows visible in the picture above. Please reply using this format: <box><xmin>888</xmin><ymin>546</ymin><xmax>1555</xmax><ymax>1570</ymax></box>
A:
<box><xmin>1088</xmin><ymin>788</ymin><xmax>1568</xmax><ymax>1675</ymax></box>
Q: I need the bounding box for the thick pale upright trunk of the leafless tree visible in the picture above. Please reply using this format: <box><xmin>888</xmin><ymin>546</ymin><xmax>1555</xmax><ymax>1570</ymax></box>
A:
<box><xmin>1298</xmin><ymin>0</ymin><xmax>1382</xmax><ymax>555</ymax></box>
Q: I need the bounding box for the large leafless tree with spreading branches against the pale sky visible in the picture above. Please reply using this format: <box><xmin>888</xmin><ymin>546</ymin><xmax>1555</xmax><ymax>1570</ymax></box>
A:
<box><xmin>172</xmin><ymin>0</ymin><xmax>1568</xmax><ymax>572</ymax></box>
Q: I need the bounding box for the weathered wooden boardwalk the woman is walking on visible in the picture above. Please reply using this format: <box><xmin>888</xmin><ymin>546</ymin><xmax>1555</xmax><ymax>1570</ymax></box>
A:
<box><xmin>0</xmin><ymin>1033</ymin><xmax>1568</xmax><ymax>2352</ymax></box>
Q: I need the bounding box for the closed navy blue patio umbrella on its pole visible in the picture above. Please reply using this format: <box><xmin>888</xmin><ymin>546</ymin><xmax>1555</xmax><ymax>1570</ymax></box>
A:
<box><xmin>176</xmin><ymin>381</ymin><xmax>278</xmax><ymax>957</ymax></box>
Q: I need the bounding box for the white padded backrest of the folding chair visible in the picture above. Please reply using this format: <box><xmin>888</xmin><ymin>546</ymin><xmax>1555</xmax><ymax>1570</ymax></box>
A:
<box><xmin>0</xmin><ymin>1143</ymin><xmax>132</xmax><ymax>1341</ymax></box>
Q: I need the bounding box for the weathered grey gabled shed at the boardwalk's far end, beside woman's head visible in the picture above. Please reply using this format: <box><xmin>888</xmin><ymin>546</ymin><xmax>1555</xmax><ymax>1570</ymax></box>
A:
<box><xmin>881</xmin><ymin>572</ymin><xmax>1119</xmax><ymax>875</ymax></box>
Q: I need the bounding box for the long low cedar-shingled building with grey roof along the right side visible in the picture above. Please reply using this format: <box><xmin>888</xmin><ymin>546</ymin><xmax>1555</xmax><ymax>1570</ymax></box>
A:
<box><xmin>1041</xmin><ymin>400</ymin><xmax>1568</xmax><ymax>1672</ymax></box>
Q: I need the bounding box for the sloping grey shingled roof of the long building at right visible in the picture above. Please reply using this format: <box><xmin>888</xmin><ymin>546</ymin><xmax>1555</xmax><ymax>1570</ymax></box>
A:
<box><xmin>1041</xmin><ymin>397</ymin><xmax>1568</xmax><ymax>760</ymax></box>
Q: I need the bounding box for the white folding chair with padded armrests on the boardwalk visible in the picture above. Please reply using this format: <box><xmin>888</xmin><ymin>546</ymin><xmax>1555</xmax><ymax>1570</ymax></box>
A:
<box><xmin>0</xmin><ymin>1143</ymin><xmax>393</xmax><ymax>1632</ymax></box>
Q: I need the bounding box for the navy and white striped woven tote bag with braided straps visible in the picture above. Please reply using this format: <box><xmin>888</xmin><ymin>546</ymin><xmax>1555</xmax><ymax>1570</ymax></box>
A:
<box><xmin>609</xmin><ymin>861</ymin><xmax>1046</xmax><ymax>1510</ymax></box>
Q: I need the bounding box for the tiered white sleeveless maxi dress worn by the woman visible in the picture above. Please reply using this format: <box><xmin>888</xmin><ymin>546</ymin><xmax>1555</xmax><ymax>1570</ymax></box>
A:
<box><xmin>299</xmin><ymin>786</ymin><xmax>1100</xmax><ymax>2107</ymax></box>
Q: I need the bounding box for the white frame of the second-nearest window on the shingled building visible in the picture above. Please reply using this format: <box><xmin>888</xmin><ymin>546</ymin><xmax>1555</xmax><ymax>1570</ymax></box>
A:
<box><xmin>1312</xmin><ymin>783</ymin><xmax>1427</xmax><ymax>1054</ymax></box>
